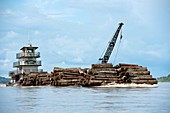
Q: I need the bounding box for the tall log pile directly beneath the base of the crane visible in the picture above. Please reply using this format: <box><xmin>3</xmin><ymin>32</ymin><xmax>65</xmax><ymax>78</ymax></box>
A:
<box><xmin>82</xmin><ymin>64</ymin><xmax>118</xmax><ymax>86</ymax></box>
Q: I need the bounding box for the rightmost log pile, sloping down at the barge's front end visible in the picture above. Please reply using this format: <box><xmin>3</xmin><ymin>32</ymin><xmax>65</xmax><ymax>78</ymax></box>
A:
<box><xmin>115</xmin><ymin>64</ymin><xmax>157</xmax><ymax>84</ymax></box>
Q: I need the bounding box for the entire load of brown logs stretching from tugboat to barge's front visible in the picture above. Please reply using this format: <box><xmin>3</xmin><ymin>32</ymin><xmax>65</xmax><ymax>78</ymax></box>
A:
<box><xmin>17</xmin><ymin>64</ymin><xmax>157</xmax><ymax>86</ymax></box>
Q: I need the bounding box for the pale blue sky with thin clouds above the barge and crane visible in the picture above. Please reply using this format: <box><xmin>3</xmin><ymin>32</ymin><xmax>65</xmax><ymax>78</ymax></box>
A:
<box><xmin>0</xmin><ymin>0</ymin><xmax>170</xmax><ymax>77</ymax></box>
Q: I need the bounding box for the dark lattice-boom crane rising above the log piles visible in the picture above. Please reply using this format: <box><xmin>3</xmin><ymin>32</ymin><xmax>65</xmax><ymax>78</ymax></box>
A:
<box><xmin>99</xmin><ymin>22</ymin><xmax>124</xmax><ymax>64</ymax></box>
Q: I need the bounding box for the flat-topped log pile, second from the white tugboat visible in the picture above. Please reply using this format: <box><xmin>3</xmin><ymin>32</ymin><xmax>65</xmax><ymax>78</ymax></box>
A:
<box><xmin>51</xmin><ymin>67</ymin><xmax>84</xmax><ymax>86</ymax></box>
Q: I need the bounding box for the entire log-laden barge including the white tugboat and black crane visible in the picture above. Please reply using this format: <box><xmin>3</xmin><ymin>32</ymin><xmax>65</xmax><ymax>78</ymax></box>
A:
<box><xmin>9</xmin><ymin>23</ymin><xmax>157</xmax><ymax>87</ymax></box>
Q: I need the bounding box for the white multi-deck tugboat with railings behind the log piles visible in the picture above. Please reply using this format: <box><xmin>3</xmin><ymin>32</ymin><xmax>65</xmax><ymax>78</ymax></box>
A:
<box><xmin>8</xmin><ymin>44</ymin><xmax>43</xmax><ymax>86</ymax></box>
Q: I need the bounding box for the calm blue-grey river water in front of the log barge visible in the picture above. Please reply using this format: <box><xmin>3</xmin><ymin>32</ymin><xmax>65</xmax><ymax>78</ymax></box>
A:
<box><xmin>0</xmin><ymin>83</ymin><xmax>170</xmax><ymax>113</ymax></box>
